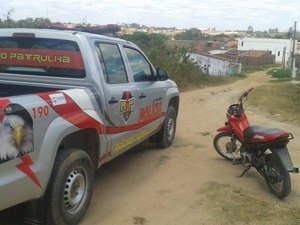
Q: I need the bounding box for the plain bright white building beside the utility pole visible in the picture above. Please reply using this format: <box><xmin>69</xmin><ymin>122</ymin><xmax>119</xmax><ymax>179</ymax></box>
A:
<box><xmin>238</xmin><ymin>38</ymin><xmax>297</xmax><ymax>65</ymax></box>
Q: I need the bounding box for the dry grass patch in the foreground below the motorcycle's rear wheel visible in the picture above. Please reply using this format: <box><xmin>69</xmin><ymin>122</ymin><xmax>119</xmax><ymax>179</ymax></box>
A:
<box><xmin>198</xmin><ymin>182</ymin><xmax>300</xmax><ymax>225</ymax></box>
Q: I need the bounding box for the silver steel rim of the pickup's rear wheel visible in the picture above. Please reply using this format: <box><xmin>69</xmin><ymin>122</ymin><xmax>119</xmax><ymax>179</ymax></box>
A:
<box><xmin>64</xmin><ymin>167</ymin><xmax>89</xmax><ymax>215</ymax></box>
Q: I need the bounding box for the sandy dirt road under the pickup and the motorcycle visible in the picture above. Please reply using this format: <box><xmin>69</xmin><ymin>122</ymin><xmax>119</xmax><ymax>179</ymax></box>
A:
<box><xmin>0</xmin><ymin>72</ymin><xmax>300</xmax><ymax>225</ymax></box>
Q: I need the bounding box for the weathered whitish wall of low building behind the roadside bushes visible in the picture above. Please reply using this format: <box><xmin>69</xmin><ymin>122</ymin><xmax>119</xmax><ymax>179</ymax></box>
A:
<box><xmin>189</xmin><ymin>53</ymin><xmax>242</xmax><ymax>76</ymax></box>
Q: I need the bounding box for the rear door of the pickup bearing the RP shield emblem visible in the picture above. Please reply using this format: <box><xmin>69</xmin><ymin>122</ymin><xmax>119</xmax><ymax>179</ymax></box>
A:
<box><xmin>96</xmin><ymin>42</ymin><xmax>138</xmax><ymax>157</ymax></box>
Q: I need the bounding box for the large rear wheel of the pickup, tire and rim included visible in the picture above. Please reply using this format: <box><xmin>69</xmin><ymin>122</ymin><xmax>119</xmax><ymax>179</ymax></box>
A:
<box><xmin>45</xmin><ymin>149</ymin><xmax>94</xmax><ymax>225</ymax></box>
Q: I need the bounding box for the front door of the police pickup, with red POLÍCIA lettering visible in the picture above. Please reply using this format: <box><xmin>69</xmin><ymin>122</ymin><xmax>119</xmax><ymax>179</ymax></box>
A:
<box><xmin>124</xmin><ymin>46</ymin><xmax>167</xmax><ymax>130</ymax></box>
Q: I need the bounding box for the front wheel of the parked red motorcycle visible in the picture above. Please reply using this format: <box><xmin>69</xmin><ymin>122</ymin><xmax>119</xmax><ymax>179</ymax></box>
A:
<box><xmin>213</xmin><ymin>132</ymin><xmax>242</xmax><ymax>161</ymax></box>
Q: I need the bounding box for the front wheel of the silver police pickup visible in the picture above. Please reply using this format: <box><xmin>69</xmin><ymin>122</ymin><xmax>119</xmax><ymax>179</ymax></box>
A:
<box><xmin>156</xmin><ymin>105</ymin><xmax>177</xmax><ymax>148</ymax></box>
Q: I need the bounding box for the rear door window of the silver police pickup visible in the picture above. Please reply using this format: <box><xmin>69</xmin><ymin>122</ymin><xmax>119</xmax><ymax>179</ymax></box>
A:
<box><xmin>96</xmin><ymin>43</ymin><xmax>128</xmax><ymax>84</ymax></box>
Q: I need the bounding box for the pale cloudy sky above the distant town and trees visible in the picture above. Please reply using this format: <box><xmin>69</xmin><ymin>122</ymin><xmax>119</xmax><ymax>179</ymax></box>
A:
<box><xmin>0</xmin><ymin>0</ymin><xmax>300</xmax><ymax>31</ymax></box>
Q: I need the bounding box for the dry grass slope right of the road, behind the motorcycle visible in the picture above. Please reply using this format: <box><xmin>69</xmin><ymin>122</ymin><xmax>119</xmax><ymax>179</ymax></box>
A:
<box><xmin>247</xmin><ymin>82</ymin><xmax>300</xmax><ymax>122</ymax></box>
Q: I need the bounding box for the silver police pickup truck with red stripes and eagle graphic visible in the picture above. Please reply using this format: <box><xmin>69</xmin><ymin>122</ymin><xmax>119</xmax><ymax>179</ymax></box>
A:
<box><xmin>0</xmin><ymin>29</ymin><xmax>179</xmax><ymax>225</ymax></box>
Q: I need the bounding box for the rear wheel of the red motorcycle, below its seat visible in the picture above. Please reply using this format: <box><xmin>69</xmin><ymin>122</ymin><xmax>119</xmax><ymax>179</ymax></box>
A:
<box><xmin>265</xmin><ymin>154</ymin><xmax>291</xmax><ymax>199</ymax></box>
